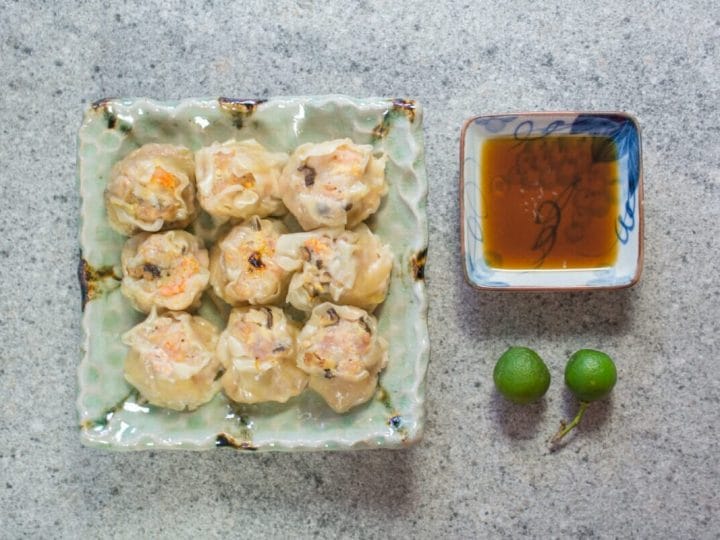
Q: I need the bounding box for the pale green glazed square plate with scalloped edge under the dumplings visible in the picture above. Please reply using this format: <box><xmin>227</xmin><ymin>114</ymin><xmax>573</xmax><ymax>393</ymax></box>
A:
<box><xmin>77</xmin><ymin>96</ymin><xmax>428</xmax><ymax>451</ymax></box>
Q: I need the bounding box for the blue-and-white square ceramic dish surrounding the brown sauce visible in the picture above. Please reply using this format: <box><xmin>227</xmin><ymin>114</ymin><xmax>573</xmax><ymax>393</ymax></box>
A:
<box><xmin>460</xmin><ymin>112</ymin><xmax>643</xmax><ymax>290</ymax></box>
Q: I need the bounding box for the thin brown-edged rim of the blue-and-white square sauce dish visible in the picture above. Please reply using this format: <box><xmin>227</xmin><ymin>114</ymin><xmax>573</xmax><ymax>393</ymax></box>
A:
<box><xmin>458</xmin><ymin>110</ymin><xmax>645</xmax><ymax>292</ymax></box>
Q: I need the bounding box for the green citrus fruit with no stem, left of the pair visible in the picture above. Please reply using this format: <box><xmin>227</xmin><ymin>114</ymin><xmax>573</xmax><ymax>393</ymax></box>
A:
<box><xmin>493</xmin><ymin>347</ymin><xmax>550</xmax><ymax>403</ymax></box>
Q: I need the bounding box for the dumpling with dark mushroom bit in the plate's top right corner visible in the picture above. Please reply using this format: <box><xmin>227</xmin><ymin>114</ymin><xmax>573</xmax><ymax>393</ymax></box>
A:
<box><xmin>280</xmin><ymin>139</ymin><xmax>388</xmax><ymax>231</ymax></box>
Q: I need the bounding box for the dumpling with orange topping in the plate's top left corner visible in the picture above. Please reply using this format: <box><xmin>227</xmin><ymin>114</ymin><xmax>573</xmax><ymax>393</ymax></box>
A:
<box><xmin>105</xmin><ymin>144</ymin><xmax>197</xmax><ymax>236</ymax></box>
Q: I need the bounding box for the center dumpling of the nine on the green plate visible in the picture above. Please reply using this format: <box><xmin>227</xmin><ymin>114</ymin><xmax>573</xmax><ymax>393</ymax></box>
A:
<box><xmin>210</xmin><ymin>216</ymin><xmax>290</xmax><ymax>306</ymax></box>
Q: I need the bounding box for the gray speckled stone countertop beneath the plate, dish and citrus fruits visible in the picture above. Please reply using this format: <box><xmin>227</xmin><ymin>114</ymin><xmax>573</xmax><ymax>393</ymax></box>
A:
<box><xmin>0</xmin><ymin>0</ymin><xmax>720</xmax><ymax>538</ymax></box>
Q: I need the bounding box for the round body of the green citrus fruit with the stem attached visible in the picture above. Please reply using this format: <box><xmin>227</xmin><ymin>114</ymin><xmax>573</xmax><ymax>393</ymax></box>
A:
<box><xmin>565</xmin><ymin>349</ymin><xmax>617</xmax><ymax>401</ymax></box>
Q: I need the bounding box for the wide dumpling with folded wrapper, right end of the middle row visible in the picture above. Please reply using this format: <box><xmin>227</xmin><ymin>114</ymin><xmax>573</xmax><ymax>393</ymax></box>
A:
<box><xmin>277</xmin><ymin>223</ymin><xmax>393</xmax><ymax>311</ymax></box>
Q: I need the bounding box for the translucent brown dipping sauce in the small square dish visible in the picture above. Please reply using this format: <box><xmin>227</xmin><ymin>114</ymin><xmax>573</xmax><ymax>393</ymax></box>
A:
<box><xmin>480</xmin><ymin>135</ymin><xmax>620</xmax><ymax>270</ymax></box>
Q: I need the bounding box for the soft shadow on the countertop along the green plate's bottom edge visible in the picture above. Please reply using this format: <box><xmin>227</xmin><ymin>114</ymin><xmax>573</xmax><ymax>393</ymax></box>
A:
<box><xmin>73</xmin><ymin>442</ymin><xmax>419</xmax><ymax>524</ymax></box>
